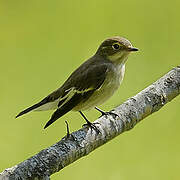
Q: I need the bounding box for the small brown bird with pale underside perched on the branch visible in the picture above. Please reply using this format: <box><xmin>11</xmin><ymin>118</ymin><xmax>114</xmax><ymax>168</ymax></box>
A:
<box><xmin>16</xmin><ymin>36</ymin><xmax>138</xmax><ymax>129</ymax></box>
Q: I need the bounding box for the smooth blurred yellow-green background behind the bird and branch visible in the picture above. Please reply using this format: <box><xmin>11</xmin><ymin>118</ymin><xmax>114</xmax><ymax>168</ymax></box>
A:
<box><xmin>0</xmin><ymin>0</ymin><xmax>180</xmax><ymax>180</ymax></box>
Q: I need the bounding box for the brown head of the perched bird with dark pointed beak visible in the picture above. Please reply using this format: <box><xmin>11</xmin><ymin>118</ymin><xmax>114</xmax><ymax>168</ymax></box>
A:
<box><xmin>96</xmin><ymin>36</ymin><xmax>138</xmax><ymax>64</ymax></box>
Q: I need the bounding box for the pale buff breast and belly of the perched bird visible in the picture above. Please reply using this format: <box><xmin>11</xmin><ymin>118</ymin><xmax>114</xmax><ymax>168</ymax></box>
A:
<box><xmin>73</xmin><ymin>65</ymin><xmax>125</xmax><ymax>111</ymax></box>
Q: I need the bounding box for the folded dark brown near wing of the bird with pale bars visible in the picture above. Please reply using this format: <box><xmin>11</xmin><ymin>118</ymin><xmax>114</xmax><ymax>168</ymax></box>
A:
<box><xmin>44</xmin><ymin>61</ymin><xmax>108</xmax><ymax>128</ymax></box>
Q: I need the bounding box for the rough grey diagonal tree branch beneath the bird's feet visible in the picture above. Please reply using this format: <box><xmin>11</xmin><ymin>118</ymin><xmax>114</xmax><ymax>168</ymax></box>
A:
<box><xmin>0</xmin><ymin>66</ymin><xmax>180</xmax><ymax>180</ymax></box>
